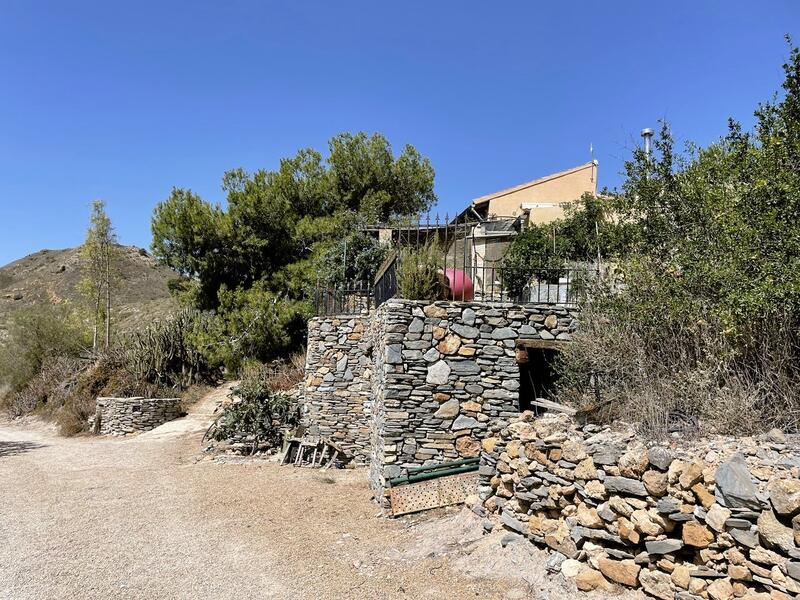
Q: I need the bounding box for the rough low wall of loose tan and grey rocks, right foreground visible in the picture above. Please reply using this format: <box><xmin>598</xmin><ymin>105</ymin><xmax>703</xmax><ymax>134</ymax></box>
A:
<box><xmin>473</xmin><ymin>412</ymin><xmax>800</xmax><ymax>600</ymax></box>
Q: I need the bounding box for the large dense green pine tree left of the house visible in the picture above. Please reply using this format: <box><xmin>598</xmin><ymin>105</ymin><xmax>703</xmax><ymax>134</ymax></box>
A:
<box><xmin>152</xmin><ymin>133</ymin><xmax>436</xmax><ymax>360</ymax></box>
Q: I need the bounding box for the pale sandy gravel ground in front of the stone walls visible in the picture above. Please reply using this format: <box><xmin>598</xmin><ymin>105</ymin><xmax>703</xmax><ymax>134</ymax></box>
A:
<box><xmin>0</xmin><ymin>390</ymin><xmax>636</xmax><ymax>600</ymax></box>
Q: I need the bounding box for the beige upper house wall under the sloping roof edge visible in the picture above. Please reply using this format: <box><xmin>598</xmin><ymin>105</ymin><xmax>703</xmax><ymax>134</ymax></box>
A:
<box><xmin>475</xmin><ymin>163</ymin><xmax>597</xmax><ymax>223</ymax></box>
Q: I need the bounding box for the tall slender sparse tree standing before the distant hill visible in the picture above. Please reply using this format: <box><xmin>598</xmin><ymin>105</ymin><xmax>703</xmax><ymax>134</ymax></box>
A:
<box><xmin>80</xmin><ymin>200</ymin><xmax>120</xmax><ymax>352</ymax></box>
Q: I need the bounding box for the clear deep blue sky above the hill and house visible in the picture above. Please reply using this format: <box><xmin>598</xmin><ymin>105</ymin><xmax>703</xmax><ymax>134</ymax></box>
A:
<box><xmin>0</xmin><ymin>0</ymin><xmax>800</xmax><ymax>264</ymax></box>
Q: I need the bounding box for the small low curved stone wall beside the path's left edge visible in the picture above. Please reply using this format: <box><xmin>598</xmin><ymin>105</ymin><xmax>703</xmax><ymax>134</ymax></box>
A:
<box><xmin>93</xmin><ymin>398</ymin><xmax>181</xmax><ymax>435</ymax></box>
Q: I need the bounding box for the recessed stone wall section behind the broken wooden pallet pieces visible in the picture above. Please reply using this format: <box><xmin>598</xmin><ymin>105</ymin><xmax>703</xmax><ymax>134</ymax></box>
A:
<box><xmin>303</xmin><ymin>315</ymin><xmax>372</xmax><ymax>464</ymax></box>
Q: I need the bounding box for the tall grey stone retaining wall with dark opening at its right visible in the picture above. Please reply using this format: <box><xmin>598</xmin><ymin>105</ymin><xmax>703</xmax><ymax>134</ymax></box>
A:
<box><xmin>370</xmin><ymin>299</ymin><xmax>577</xmax><ymax>497</ymax></box>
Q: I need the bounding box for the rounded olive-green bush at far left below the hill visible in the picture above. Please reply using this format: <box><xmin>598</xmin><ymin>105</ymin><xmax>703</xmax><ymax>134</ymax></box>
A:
<box><xmin>0</xmin><ymin>303</ymin><xmax>91</xmax><ymax>392</ymax></box>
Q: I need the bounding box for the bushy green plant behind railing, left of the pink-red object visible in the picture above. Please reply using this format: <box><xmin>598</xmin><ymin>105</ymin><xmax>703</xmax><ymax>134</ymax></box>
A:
<box><xmin>397</xmin><ymin>241</ymin><xmax>444</xmax><ymax>300</ymax></box>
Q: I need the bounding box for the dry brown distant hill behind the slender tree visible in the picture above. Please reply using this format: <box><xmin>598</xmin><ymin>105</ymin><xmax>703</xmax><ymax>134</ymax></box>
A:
<box><xmin>0</xmin><ymin>246</ymin><xmax>177</xmax><ymax>343</ymax></box>
